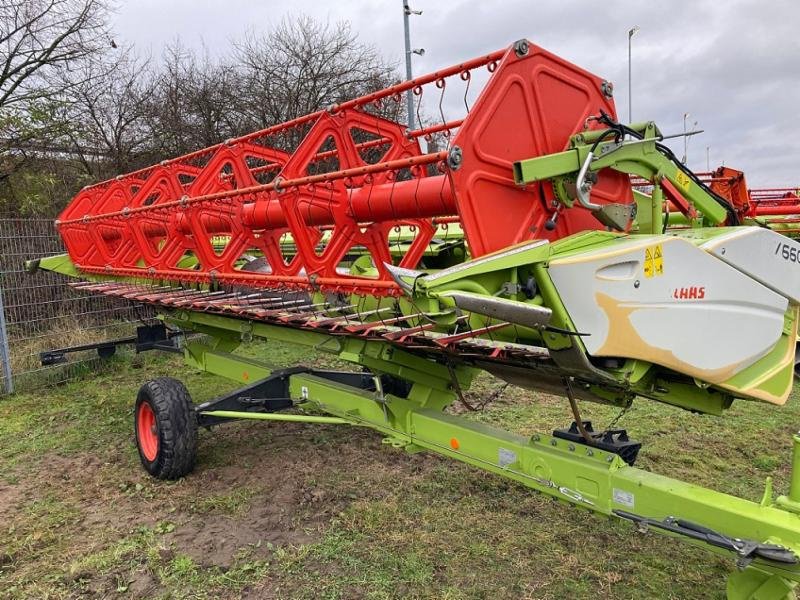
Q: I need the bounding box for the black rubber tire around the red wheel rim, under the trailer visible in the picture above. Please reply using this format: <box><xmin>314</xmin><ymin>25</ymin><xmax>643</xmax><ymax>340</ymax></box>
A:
<box><xmin>133</xmin><ymin>377</ymin><xmax>197</xmax><ymax>479</ymax></box>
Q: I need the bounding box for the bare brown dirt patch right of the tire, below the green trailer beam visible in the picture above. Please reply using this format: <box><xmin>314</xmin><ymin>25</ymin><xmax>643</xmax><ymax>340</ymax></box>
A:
<box><xmin>161</xmin><ymin>424</ymin><xmax>432</xmax><ymax>568</ymax></box>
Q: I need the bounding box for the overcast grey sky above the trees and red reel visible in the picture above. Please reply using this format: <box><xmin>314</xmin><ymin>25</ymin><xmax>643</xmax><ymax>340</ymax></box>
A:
<box><xmin>114</xmin><ymin>0</ymin><xmax>800</xmax><ymax>187</ymax></box>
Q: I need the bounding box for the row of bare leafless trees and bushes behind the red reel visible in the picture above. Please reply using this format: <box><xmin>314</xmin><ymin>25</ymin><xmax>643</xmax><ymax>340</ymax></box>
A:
<box><xmin>0</xmin><ymin>12</ymin><xmax>404</xmax><ymax>215</ymax></box>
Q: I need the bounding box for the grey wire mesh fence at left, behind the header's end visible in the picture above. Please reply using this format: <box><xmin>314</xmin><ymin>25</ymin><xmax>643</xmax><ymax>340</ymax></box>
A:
<box><xmin>0</xmin><ymin>219</ymin><xmax>154</xmax><ymax>394</ymax></box>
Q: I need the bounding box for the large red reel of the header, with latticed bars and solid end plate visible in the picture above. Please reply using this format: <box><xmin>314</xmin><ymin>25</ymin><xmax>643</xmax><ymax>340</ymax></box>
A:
<box><xmin>53</xmin><ymin>41</ymin><xmax>632</xmax><ymax>295</ymax></box>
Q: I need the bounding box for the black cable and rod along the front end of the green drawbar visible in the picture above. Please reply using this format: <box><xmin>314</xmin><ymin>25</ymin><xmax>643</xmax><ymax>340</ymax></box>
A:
<box><xmin>612</xmin><ymin>510</ymin><xmax>800</xmax><ymax>569</ymax></box>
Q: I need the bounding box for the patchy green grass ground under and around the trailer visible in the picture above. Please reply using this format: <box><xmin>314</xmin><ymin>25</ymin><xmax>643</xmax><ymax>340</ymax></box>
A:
<box><xmin>0</xmin><ymin>346</ymin><xmax>800</xmax><ymax>599</ymax></box>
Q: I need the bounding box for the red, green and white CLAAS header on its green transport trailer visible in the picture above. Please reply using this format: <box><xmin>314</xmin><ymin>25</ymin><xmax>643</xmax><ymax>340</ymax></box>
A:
<box><xmin>31</xmin><ymin>40</ymin><xmax>800</xmax><ymax>599</ymax></box>
